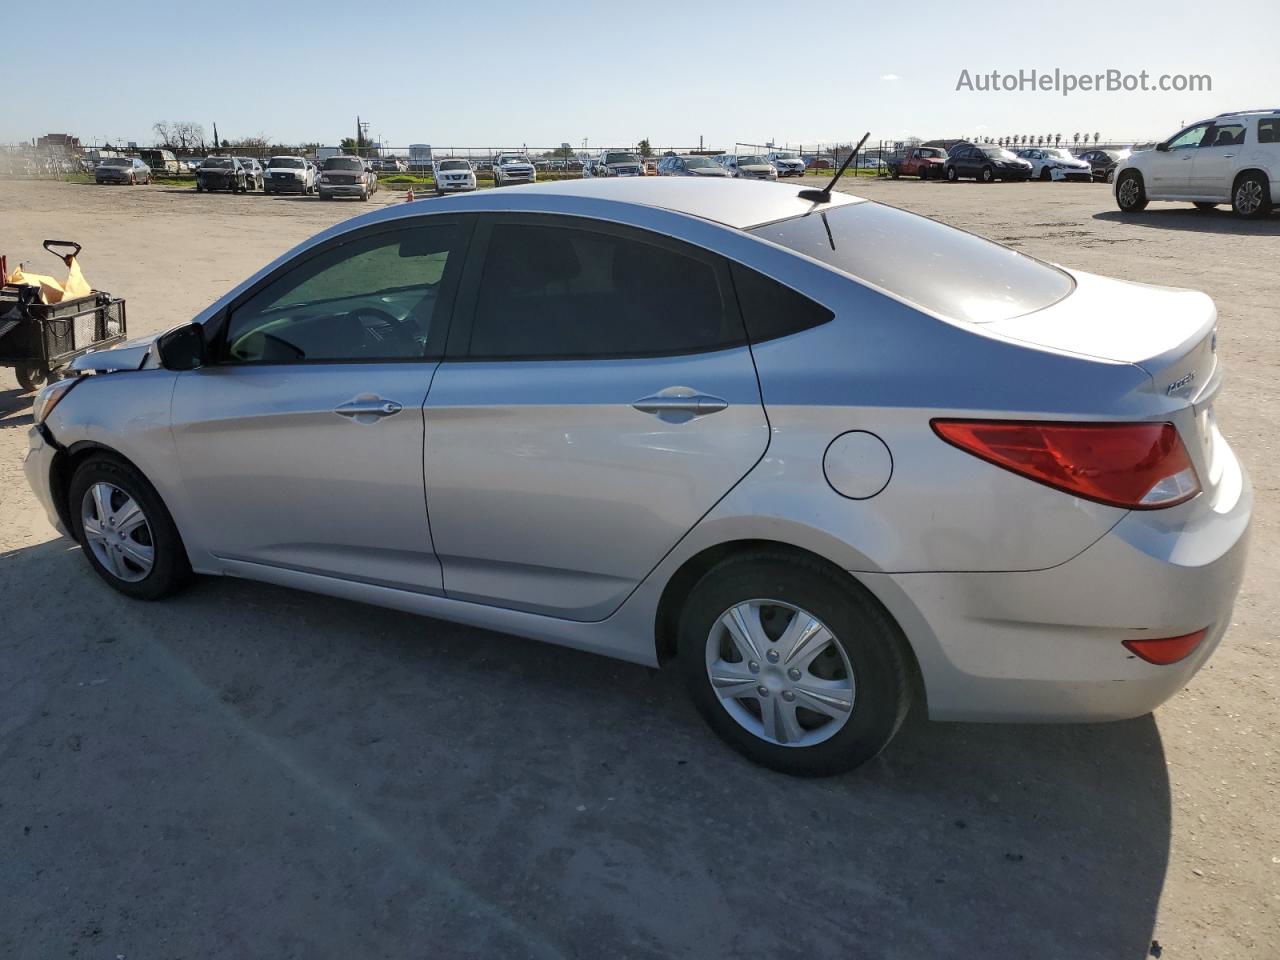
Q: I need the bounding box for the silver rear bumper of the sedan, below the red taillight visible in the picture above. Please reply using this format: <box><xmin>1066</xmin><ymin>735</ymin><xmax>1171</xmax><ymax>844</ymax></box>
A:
<box><xmin>856</xmin><ymin>443</ymin><xmax>1253</xmax><ymax>721</ymax></box>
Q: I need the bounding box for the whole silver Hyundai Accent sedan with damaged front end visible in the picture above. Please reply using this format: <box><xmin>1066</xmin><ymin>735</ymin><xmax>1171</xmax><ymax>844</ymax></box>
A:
<box><xmin>26</xmin><ymin>178</ymin><xmax>1252</xmax><ymax>774</ymax></box>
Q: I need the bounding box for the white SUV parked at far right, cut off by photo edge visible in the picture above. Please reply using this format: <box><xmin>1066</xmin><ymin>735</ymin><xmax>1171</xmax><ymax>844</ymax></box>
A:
<box><xmin>1115</xmin><ymin>108</ymin><xmax>1280</xmax><ymax>219</ymax></box>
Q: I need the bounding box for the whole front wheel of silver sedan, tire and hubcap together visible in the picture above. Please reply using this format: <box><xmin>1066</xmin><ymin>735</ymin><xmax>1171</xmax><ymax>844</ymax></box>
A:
<box><xmin>68</xmin><ymin>456</ymin><xmax>191</xmax><ymax>600</ymax></box>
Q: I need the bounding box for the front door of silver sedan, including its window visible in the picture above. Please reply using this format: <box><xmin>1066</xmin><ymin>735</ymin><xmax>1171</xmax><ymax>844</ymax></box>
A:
<box><xmin>173</xmin><ymin>218</ymin><xmax>465</xmax><ymax>593</ymax></box>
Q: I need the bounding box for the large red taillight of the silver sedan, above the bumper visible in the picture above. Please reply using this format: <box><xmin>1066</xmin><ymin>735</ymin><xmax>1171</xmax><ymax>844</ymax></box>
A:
<box><xmin>932</xmin><ymin>420</ymin><xmax>1201</xmax><ymax>509</ymax></box>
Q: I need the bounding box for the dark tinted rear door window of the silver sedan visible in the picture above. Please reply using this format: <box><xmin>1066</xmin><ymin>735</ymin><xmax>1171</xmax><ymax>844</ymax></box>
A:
<box><xmin>470</xmin><ymin>223</ymin><xmax>745</xmax><ymax>360</ymax></box>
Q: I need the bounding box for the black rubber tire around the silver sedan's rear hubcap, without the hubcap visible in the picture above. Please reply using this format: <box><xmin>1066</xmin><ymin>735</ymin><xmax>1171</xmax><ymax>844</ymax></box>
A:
<box><xmin>678</xmin><ymin>550</ymin><xmax>911</xmax><ymax>777</ymax></box>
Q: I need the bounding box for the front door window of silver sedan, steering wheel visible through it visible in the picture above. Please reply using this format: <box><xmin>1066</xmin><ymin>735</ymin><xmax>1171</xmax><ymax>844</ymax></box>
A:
<box><xmin>221</xmin><ymin>224</ymin><xmax>462</xmax><ymax>364</ymax></box>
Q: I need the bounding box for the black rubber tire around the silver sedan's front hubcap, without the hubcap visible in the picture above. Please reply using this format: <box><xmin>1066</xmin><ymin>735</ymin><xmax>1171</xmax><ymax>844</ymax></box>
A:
<box><xmin>67</xmin><ymin>454</ymin><xmax>191</xmax><ymax>600</ymax></box>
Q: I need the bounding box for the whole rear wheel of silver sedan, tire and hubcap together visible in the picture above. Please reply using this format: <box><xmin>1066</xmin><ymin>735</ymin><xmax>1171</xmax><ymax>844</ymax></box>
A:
<box><xmin>678</xmin><ymin>550</ymin><xmax>910</xmax><ymax>777</ymax></box>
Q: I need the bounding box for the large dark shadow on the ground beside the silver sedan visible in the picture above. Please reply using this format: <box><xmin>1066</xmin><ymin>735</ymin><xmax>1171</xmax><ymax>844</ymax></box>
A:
<box><xmin>0</xmin><ymin>540</ymin><xmax>1170</xmax><ymax>960</ymax></box>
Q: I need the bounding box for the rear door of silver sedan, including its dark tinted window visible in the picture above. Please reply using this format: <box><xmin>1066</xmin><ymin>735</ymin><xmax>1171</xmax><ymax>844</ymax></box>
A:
<box><xmin>425</xmin><ymin>214</ymin><xmax>768</xmax><ymax>621</ymax></box>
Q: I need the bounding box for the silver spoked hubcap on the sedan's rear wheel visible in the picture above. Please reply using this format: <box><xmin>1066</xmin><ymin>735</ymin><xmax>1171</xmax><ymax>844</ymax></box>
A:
<box><xmin>707</xmin><ymin>600</ymin><xmax>855</xmax><ymax>746</ymax></box>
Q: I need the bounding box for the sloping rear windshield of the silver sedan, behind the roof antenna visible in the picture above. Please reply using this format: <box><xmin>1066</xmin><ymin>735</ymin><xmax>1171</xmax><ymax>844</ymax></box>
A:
<box><xmin>751</xmin><ymin>202</ymin><xmax>1074</xmax><ymax>324</ymax></box>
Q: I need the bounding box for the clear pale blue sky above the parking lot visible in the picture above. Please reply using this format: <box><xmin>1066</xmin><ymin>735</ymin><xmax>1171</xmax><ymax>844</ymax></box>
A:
<box><xmin>0</xmin><ymin>0</ymin><xmax>1280</xmax><ymax>147</ymax></box>
